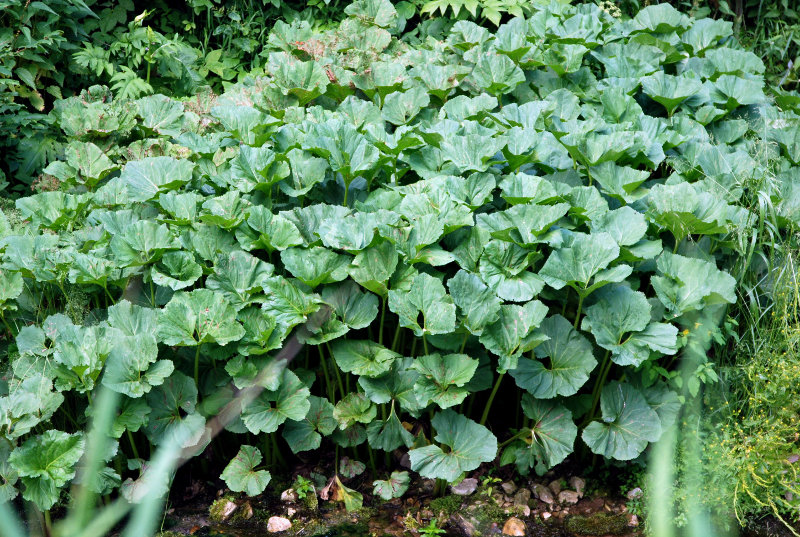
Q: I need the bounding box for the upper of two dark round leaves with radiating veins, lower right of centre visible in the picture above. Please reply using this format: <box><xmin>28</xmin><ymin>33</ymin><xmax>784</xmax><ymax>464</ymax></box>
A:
<box><xmin>510</xmin><ymin>315</ymin><xmax>597</xmax><ymax>399</ymax></box>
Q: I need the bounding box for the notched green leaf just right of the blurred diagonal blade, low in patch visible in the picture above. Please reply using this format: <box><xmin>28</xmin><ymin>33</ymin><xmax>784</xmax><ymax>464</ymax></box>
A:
<box><xmin>242</xmin><ymin>369</ymin><xmax>311</xmax><ymax>434</ymax></box>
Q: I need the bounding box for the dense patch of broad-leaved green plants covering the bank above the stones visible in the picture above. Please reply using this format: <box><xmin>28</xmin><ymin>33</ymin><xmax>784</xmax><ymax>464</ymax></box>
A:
<box><xmin>0</xmin><ymin>0</ymin><xmax>800</xmax><ymax>528</ymax></box>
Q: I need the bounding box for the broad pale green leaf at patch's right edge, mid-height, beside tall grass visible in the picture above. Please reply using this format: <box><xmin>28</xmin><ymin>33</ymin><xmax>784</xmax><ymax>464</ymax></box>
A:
<box><xmin>651</xmin><ymin>252</ymin><xmax>736</xmax><ymax>317</ymax></box>
